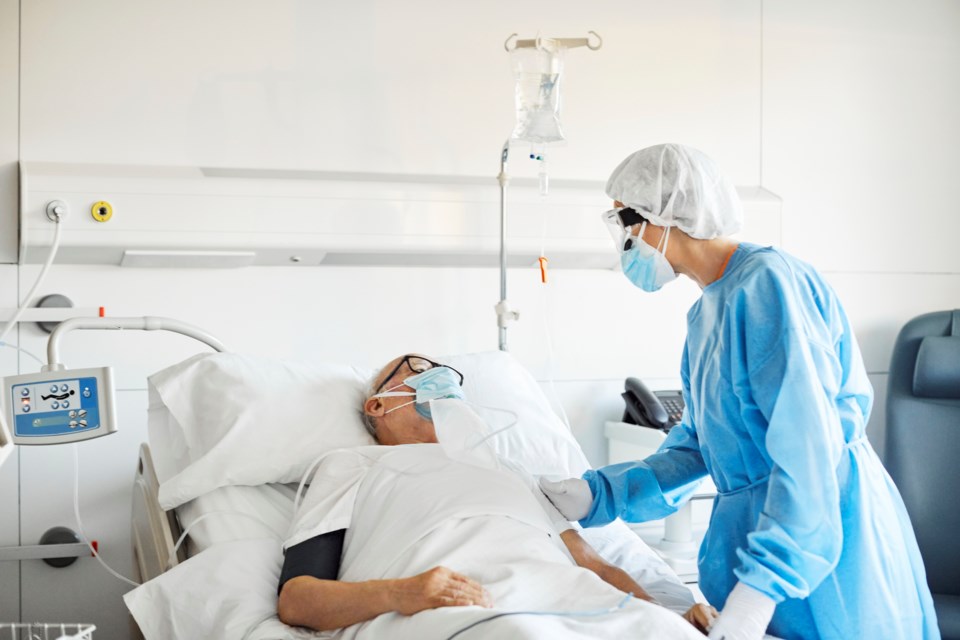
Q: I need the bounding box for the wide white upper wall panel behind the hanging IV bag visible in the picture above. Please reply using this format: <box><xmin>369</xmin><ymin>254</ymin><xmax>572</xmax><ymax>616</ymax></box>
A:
<box><xmin>22</xmin><ymin>0</ymin><xmax>760</xmax><ymax>184</ymax></box>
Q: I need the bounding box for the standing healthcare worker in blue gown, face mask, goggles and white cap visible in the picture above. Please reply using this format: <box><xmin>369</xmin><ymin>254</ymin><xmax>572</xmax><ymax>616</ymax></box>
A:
<box><xmin>541</xmin><ymin>144</ymin><xmax>940</xmax><ymax>640</ymax></box>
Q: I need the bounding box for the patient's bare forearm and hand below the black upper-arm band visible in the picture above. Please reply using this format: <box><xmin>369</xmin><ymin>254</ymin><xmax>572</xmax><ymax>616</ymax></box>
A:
<box><xmin>277</xmin><ymin>567</ymin><xmax>492</xmax><ymax>631</ymax></box>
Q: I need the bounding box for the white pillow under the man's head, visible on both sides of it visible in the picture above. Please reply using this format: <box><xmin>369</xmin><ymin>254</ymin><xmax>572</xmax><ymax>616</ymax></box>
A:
<box><xmin>148</xmin><ymin>351</ymin><xmax>589</xmax><ymax>509</ymax></box>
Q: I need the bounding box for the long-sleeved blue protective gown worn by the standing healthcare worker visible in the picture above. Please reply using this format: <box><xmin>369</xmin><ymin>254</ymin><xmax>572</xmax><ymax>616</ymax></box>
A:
<box><xmin>580</xmin><ymin>243</ymin><xmax>940</xmax><ymax>640</ymax></box>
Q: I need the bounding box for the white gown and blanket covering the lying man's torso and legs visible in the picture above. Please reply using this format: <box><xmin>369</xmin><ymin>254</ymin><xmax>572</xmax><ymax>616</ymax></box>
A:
<box><xmin>286</xmin><ymin>445</ymin><xmax>703</xmax><ymax>640</ymax></box>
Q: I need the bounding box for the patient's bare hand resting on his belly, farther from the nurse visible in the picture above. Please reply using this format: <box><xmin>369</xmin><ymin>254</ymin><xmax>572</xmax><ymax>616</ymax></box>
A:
<box><xmin>391</xmin><ymin>567</ymin><xmax>493</xmax><ymax>616</ymax></box>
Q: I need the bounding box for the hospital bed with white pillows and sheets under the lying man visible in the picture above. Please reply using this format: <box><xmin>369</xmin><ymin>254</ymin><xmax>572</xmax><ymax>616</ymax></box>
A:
<box><xmin>124</xmin><ymin>352</ymin><xmax>694</xmax><ymax>640</ymax></box>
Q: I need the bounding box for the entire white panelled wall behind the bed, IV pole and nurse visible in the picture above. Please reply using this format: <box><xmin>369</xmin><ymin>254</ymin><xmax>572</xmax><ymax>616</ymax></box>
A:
<box><xmin>0</xmin><ymin>0</ymin><xmax>960</xmax><ymax>639</ymax></box>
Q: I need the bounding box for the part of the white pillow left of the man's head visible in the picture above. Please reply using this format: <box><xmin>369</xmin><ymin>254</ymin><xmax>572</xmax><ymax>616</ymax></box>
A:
<box><xmin>147</xmin><ymin>353</ymin><xmax>374</xmax><ymax>509</ymax></box>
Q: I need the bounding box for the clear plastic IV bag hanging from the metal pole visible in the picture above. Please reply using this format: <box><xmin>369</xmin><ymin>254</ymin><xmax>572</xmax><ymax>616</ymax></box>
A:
<box><xmin>510</xmin><ymin>47</ymin><xmax>564</xmax><ymax>144</ymax></box>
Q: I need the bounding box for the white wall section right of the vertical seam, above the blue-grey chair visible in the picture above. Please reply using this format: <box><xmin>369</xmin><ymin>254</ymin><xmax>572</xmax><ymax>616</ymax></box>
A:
<box><xmin>762</xmin><ymin>0</ymin><xmax>960</xmax><ymax>452</ymax></box>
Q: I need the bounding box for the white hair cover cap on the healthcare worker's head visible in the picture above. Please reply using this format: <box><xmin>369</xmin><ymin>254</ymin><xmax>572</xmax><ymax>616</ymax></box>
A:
<box><xmin>606</xmin><ymin>144</ymin><xmax>743</xmax><ymax>240</ymax></box>
